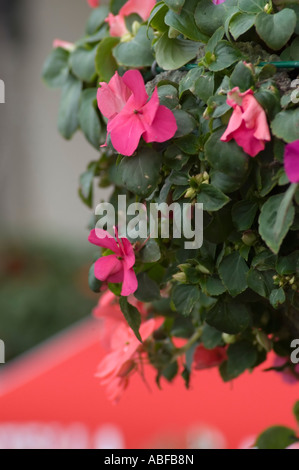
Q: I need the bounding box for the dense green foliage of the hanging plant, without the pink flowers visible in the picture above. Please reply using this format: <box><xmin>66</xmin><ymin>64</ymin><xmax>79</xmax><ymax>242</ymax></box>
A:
<box><xmin>43</xmin><ymin>0</ymin><xmax>299</xmax><ymax>383</ymax></box>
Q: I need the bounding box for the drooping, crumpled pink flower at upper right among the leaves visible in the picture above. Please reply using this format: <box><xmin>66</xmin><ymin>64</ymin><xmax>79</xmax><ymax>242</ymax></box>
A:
<box><xmin>221</xmin><ymin>87</ymin><xmax>271</xmax><ymax>157</ymax></box>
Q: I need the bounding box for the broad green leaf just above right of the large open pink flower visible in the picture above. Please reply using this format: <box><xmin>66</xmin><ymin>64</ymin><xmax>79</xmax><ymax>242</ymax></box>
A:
<box><xmin>155</xmin><ymin>33</ymin><xmax>199</xmax><ymax>70</ymax></box>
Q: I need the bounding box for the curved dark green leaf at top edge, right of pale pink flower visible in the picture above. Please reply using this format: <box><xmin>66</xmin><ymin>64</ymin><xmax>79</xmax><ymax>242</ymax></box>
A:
<box><xmin>165</xmin><ymin>0</ymin><xmax>209</xmax><ymax>42</ymax></box>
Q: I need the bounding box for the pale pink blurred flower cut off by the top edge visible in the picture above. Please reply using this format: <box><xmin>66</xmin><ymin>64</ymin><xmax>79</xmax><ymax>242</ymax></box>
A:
<box><xmin>106</xmin><ymin>0</ymin><xmax>156</xmax><ymax>37</ymax></box>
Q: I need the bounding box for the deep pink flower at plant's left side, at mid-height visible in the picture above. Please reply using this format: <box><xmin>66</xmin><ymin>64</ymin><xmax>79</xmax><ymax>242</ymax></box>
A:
<box><xmin>88</xmin><ymin>229</ymin><xmax>138</xmax><ymax>296</ymax></box>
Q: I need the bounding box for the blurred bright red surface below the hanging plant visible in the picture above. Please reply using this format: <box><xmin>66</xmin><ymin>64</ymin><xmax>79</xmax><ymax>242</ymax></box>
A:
<box><xmin>0</xmin><ymin>320</ymin><xmax>299</xmax><ymax>448</ymax></box>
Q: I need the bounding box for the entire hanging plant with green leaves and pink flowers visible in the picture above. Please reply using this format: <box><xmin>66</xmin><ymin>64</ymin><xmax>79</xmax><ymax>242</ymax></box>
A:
<box><xmin>43</xmin><ymin>0</ymin><xmax>299</xmax><ymax>401</ymax></box>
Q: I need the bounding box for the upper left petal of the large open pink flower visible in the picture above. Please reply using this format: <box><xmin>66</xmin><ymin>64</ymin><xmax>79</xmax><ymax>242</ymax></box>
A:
<box><xmin>97</xmin><ymin>72</ymin><xmax>132</xmax><ymax>119</ymax></box>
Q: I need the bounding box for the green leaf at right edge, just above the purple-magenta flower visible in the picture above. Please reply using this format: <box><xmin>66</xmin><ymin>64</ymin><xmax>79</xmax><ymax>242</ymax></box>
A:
<box><xmin>271</xmin><ymin>108</ymin><xmax>299</xmax><ymax>143</ymax></box>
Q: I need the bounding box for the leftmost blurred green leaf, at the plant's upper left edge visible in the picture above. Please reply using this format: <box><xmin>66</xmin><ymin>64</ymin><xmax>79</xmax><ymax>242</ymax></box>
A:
<box><xmin>42</xmin><ymin>47</ymin><xmax>70</xmax><ymax>88</ymax></box>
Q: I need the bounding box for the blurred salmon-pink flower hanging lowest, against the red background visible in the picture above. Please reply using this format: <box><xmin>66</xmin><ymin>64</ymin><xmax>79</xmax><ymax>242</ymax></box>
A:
<box><xmin>97</xmin><ymin>319</ymin><xmax>156</xmax><ymax>403</ymax></box>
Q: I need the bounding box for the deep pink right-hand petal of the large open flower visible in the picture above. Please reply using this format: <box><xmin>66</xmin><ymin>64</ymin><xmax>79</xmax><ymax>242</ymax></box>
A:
<box><xmin>143</xmin><ymin>106</ymin><xmax>178</xmax><ymax>142</ymax></box>
